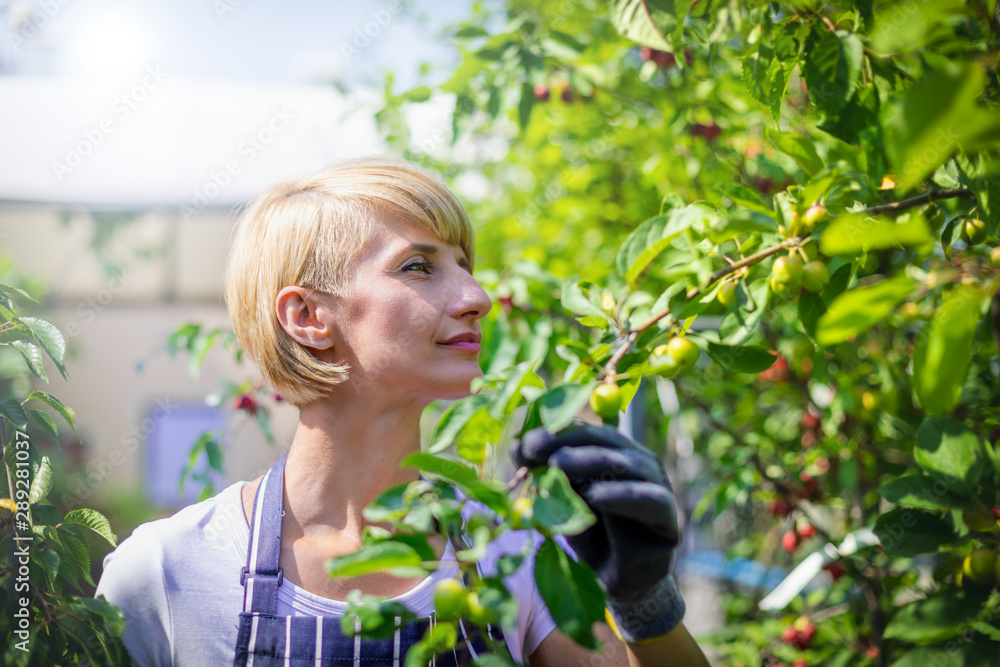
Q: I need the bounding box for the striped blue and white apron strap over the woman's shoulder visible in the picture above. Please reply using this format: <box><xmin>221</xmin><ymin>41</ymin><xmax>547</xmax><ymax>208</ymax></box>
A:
<box><xmin>240</xmin><ymin>451</ymin><xmax>288</xmax><ymax>614</ymax></box>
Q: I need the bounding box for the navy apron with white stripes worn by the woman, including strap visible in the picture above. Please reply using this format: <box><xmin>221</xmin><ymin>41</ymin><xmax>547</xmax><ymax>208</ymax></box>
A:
<box><xmin>233</xmin><ymin>452</ymin><xmax>506</xmax><ymax>667</ymax></box>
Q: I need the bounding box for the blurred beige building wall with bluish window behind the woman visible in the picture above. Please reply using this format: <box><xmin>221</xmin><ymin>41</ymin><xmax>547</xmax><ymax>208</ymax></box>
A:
<box><xmin>0</xmin><ymin>206</ymin><xmax>297</xmax><ymax>509</ymax></box>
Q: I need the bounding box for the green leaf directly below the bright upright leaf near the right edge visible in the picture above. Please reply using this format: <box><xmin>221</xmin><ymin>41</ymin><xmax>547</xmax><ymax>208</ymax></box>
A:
<box><xmin>913</xmin><ymin>417</ymin><xmax>980</xmax><ymax>485</ymax></box>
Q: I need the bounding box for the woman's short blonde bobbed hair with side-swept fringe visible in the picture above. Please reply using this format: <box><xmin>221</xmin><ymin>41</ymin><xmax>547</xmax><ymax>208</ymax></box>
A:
<box><xmin>225</xmin><ymin>158</ymin><xmax>474</xmax><ymax>406</ymax></box>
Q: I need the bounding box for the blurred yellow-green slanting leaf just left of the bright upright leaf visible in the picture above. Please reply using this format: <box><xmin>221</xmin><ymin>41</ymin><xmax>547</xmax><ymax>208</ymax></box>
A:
<box><xmin>816</xmin><ymin>274</ymin><xmax>914</xmax><ymax>345</ymax></box>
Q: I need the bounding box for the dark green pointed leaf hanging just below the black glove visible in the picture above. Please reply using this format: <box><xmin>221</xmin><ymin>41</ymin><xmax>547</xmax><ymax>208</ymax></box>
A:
<box><xmin>535</xmin><ymin>539</ymin><xmax>604</xmax><ymax>650</ymax></box>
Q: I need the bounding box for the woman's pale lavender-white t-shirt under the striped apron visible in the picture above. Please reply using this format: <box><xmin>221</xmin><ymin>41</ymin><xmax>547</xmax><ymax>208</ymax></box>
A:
<box><xmin>95</xmin><ymin>481</ymin><xmax>555</xmax><ymax>667</ymax></box>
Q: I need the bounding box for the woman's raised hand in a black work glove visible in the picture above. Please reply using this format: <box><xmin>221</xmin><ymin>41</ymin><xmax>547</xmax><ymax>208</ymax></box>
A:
<box><xmin>510</xmin><ymin>422</ymin><xmax>684</xmax><ymax>642</ymax></box>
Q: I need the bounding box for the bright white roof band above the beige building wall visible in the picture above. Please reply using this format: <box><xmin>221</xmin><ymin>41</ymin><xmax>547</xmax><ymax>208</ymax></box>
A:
<box><xmin>0</xmin><ymin>74</ymin><xmax>384</xmax><ymax>210</ymax></box>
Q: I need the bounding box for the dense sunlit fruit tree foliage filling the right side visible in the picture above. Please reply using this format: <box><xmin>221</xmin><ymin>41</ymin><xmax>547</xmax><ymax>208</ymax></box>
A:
<box><xmin>366</xmin><ymin>0</ymin><xmax>1000</xmax><ymax>667</ymax></box>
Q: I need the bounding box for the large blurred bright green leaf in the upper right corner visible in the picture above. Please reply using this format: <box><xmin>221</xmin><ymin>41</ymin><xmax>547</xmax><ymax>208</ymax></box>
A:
<box><xmin>882</xmin><ymin>63</ymin><xmax>1000</xmax><ymax>190</ymax></box>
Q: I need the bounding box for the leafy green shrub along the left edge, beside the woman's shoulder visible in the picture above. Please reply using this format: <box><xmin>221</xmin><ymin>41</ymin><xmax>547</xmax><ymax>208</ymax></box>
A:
<box><xmin>0</xmin><ymin>285</ymin><xmax>129</xmax><ymax>665</ymax></box>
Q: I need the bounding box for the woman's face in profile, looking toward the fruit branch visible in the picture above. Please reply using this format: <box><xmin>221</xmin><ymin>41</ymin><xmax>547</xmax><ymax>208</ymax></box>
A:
<box><xmin>324</xmin><ymin>221</ymin><xmax>493</xmax><ymax>402</ymax></box>
